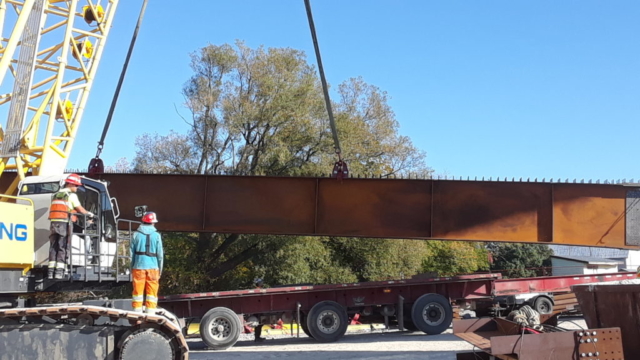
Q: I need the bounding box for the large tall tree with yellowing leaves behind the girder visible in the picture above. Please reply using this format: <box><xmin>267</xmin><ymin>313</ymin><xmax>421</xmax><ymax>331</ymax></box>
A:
<box><xmin>126</xmin><ymin>42</ymin><xmax>456</xmax><ymax>292</ymax></box>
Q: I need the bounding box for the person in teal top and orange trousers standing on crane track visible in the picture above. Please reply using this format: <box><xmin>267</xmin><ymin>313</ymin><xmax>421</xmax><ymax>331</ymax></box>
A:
<box><xmin>129</xmin><ymin>212</ymin><xmax>164</xmax><ymax>313</ymax></box>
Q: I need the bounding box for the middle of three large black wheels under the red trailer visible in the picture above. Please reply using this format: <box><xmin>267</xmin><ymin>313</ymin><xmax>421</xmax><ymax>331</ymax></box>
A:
<box><xmin>307</xmin><ymin>301</ymin><xmax>349</xmax><ymax>342</ymax></box>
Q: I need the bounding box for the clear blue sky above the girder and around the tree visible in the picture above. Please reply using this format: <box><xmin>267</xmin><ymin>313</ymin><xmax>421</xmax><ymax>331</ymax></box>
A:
<box><xmin>69</xmin><ymin>0</ymin><xmax>640</xmax><ymax>180</ymax></box>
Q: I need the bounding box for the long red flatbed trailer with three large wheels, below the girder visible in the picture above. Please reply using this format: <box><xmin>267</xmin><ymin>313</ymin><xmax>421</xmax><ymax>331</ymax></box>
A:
<box><xmin>159</xmin><ymin>273</ymin><xmax>635</xmax><ymax>349</ymax></box>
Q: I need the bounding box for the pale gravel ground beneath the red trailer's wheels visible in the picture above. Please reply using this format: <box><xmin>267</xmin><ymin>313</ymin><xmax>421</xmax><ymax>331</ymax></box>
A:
<box><xmin>189</xmin><ymin>318</ymin><xmax>586</xmax><ymax>360</ymax></box>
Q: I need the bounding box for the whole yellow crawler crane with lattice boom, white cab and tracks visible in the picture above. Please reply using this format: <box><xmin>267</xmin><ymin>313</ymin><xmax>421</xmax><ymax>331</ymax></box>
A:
<box><xmin>0</xmin><ymin>0</ymin><xmax>188</xmax><ymax>360</ymax></box>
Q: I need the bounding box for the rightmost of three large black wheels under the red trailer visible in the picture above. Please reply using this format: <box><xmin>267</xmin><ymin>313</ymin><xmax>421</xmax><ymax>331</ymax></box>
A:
<box><xmin>411</xmin><ymin>294</ymin><xmax>453</xmax><ymax>335</ymax></box>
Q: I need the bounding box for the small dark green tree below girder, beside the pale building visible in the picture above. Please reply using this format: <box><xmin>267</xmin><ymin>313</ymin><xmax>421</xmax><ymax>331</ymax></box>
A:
<box><xmin>487</xmin><ymin>243</ymin><xmax>553</xmax><ymax>278</ymax></box>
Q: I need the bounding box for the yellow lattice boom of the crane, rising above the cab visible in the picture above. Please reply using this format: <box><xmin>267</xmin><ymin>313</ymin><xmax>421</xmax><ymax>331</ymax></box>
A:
<box><xmin>0</xmin><ymin>0</ymin><xmax>118</xmax><ymax>194</ymax></box>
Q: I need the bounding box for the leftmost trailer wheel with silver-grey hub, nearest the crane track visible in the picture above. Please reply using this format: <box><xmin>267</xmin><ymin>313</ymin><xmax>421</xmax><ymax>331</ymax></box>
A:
<box><xmin>200</xmin><ymin>307</ymin><xmax>242</xmax><ymax>350</ymax></box>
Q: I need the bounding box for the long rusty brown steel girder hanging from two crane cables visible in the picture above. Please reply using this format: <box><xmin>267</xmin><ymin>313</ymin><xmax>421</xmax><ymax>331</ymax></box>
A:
<box><xmin>0</xmin><ymin>174</ymin><xmax>640</xmax><ymax>248</ymax></box>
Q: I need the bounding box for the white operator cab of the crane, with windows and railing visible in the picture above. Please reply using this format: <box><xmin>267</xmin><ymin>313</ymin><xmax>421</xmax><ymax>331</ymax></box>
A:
<box><xmin>18</xmin><ymin>174</ymin><xmax>130</xmax><ymax>290</ymax></box>
